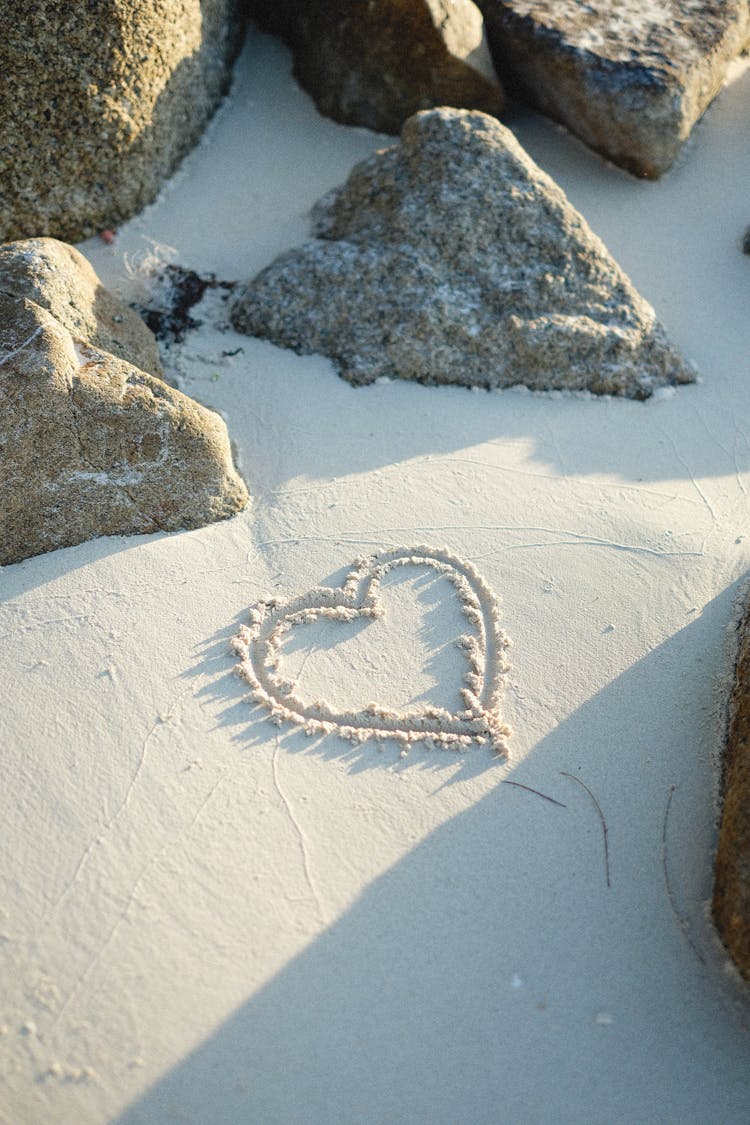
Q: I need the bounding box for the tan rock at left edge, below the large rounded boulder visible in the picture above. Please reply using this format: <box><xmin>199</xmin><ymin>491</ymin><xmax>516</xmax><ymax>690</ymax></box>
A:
<box><xmin>0</xmin><ymin>240</ymin><xmax>247</xmax><ymax>565</ymax></box>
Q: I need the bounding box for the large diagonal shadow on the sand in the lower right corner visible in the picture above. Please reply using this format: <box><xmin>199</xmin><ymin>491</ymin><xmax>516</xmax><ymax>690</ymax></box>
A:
<box><xmin>117</xmin><ymin>590</ymin><xmax>750</xmax><ymax>1125</ymax></box>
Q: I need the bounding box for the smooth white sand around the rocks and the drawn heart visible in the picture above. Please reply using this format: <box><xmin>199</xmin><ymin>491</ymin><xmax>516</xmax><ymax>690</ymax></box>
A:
<box><xmin>0</xmin><ymin>26</ymin><xmax>750</xmax><ymax>1125</ymax></box>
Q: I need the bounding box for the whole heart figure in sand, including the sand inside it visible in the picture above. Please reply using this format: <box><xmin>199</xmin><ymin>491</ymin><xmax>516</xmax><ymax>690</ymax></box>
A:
<box><xmin>232</xmin><ymin>547</ymin><xmax>510</xmax><ymax>758</ymax></box>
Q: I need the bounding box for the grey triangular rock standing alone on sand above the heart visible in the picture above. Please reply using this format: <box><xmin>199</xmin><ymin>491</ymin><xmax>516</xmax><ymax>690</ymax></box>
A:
<box><xmin>232</xmin><ymin>109</ymin><xmax>694</xmax><ymax>398</ymax></box>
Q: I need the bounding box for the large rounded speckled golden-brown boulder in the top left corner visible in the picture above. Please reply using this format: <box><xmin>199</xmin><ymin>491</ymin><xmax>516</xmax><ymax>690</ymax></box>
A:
<box><xmin>0</xmin><ymin>0</ymin><xmax>241</xmax><ymax>241</ymax></box>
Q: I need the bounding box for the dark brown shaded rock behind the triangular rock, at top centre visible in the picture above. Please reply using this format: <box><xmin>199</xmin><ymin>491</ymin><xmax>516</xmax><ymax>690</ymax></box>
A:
<box><xmin>251</xmin><ymin>0</ymin><xmax>504</xmax><ymax>133</ymax></box>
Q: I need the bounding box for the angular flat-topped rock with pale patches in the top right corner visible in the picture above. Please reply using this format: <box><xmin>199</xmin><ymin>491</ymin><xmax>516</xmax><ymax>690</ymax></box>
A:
<box><xmin>478</xmin><ymin>0</ymin><xmax>750</xmax><ymax>178</ymax></box>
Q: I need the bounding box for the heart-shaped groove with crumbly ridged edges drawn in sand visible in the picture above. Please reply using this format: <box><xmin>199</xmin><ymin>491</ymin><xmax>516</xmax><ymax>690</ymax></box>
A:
<box><xmin>232</xmin><ymin>547</ymin><xmax>510</xmax><ymax>757</ymax></box>
